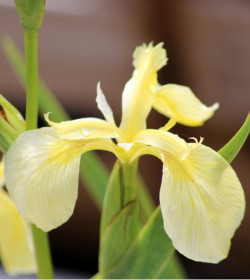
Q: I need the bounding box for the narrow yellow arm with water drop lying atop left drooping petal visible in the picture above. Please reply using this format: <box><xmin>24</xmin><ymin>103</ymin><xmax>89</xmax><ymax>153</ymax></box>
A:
<box><xmin>45</xmin><ymin>113</ymin><xmax>123</xmax><ymax>140</ymax></box>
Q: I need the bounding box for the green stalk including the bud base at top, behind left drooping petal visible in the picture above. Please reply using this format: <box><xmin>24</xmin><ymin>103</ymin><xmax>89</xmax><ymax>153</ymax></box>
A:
<box><xmin>15</xmin><ymin>0</ymin><xmax>54</xmax><ymax>279</ymax></box>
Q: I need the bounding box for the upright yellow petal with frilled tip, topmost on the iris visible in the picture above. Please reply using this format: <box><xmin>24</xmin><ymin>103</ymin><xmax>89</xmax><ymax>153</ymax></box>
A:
<box><xmin>120</xmin><ymin>43</ymin><xmax>167</xmax><ymax>142</ymax></box>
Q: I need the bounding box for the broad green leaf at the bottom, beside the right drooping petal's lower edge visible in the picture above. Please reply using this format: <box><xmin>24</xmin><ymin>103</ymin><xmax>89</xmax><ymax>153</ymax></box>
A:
<box><xmin>101</xmin><ymin>207</ymin><xmax>185</xmax><ymax>279</ymax></box>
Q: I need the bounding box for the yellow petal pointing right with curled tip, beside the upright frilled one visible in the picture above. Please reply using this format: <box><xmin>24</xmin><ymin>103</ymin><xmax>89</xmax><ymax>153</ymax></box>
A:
<box><xmin>154</xmin><ymin>84</ymin><xmax>219</xmax><ymax>126</ymax></box>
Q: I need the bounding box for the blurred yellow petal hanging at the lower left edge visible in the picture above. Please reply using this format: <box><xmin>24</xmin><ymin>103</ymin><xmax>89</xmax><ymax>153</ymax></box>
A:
<box><xmin>0</xmin><ymin>189</ymin><xmax>36</xmax><ymax>275</ymax></box>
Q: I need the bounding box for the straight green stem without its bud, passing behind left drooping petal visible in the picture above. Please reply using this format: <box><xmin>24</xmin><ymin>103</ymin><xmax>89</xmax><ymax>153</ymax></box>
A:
<box><xmin>24</xmin><ymin>32</ymin><xmax>54</xmax><ymax>279</ymax></box>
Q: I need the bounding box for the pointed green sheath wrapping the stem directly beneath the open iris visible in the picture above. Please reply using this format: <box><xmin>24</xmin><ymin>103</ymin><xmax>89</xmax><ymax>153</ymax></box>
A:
<box><xmin>99</xmin><ymin>161</ymin><xmax>139</xmax><ymax>273</ymax></box>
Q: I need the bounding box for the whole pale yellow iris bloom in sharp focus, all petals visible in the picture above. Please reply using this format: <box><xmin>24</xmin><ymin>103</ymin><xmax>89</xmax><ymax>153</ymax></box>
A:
<box><xmin>6</xmin><ymin>43</ymin><xmax>245</xmax><ymax>263</ymax></box>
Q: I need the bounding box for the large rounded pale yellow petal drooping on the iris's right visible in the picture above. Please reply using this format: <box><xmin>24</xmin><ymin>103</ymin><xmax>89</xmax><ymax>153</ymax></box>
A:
<box><xmin>160</xmin><ymin>144</ymin><xmax>245</xmax><ymax>263</ymax></box>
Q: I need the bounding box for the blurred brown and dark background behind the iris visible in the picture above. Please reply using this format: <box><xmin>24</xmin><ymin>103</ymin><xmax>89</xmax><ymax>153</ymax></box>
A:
<box><xmin>0</xmin><ymin>0</ymin><xmax>250</xmax><ymax>278</ymax></box>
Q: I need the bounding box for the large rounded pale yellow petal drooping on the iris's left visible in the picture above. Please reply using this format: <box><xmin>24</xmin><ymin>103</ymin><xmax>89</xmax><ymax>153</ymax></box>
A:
<box><xmin>5</xmin><ymin>128</ymin><xmax>82</xmax><ymax>231</ymax></box>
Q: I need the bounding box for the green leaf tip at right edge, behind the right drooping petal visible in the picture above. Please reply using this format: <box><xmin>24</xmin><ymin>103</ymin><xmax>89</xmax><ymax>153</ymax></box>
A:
<box><xmin>218</xmin><ymin>113</ymin><xmax>250</xmax><ymax>163</ymax></box>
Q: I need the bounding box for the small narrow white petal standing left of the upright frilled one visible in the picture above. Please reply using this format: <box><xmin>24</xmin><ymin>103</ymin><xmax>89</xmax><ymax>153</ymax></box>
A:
<box><xmin>96</xmin><ymin>82</ymin><xmax>115</xmax><ymax>125</ymax></box>
